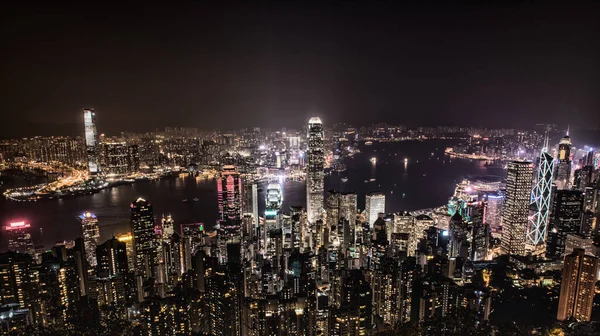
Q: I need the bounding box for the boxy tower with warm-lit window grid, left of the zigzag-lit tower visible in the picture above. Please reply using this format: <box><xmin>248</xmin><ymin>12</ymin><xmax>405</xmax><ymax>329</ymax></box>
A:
<box><xmin>501</xmin><ymin>161</ymin><xmax>533</xmax><ymax>255</ymax></box>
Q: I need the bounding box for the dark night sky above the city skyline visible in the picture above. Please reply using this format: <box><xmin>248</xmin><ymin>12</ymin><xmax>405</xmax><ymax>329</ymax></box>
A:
<box><xmin>0</xmin><ymin>1</ymin><xmax>600</xmax><ymax>137</ymax></box>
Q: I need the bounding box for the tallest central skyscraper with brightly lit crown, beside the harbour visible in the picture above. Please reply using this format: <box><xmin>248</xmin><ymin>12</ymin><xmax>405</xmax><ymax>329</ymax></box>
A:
<box><xmin>306</xmin><ymin>117</ymin><xmax>325</xmax><ymax>225</ymax></box>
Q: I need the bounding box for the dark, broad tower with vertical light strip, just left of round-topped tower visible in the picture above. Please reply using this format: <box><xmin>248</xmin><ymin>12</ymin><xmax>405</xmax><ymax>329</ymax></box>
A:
<box><xmin>96</xmin><ymin>237</ymin><xmax>129</xmax><ymax>278</ymax></box>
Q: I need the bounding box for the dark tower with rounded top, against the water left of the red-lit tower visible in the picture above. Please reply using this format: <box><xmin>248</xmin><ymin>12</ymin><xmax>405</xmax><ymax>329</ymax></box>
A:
<box><xmin>130</xmin><ymin>197</ymin><xmax>158</xmax><ymax>278</ymax></box>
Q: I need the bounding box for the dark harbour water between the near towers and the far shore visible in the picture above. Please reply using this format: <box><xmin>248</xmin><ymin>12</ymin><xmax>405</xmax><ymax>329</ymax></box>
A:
<box><xmin>0</xmin><ymin>140</ymin><xmax>505</xmax><ymax>248</ymax></box>
